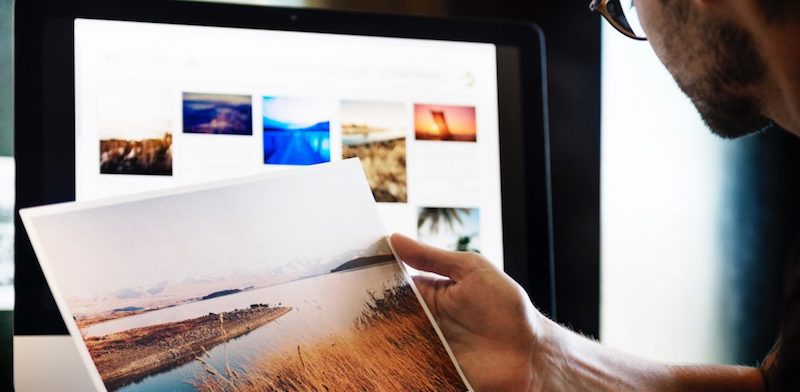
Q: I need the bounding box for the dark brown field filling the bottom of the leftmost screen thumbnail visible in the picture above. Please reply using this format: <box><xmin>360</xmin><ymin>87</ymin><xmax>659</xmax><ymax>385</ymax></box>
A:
<box><xmin>100</xmin><ymin>132</ymin><xmax>172</xmax><ymax>176</ymax></box>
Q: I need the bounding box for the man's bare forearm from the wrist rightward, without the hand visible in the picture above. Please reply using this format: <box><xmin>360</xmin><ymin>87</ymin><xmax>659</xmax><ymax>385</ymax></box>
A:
<box><xmin>533</xmin><ymin>320</ymin><xmax>765</xmax><ymax>392</ymax></box>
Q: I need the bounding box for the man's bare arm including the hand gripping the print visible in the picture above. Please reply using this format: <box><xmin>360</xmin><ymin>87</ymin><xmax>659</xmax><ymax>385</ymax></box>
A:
<box><xmin>392</xmin><ymin>235</ymin><xmax>765</xmax><ymax>392</ymax></box>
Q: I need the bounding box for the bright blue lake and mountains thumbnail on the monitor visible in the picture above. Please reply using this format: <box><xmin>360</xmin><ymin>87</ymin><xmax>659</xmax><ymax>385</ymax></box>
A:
<box><xmin>263</xmin><ymin>97</ymin><xmax>335</xmax><ymax>165</ymax></box>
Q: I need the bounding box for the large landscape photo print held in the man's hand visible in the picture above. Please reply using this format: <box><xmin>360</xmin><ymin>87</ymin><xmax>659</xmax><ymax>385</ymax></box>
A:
<box><xmin>25</xmin><ymin>160</ymin><xmax>468</xmax><ymax>391</ymax></box>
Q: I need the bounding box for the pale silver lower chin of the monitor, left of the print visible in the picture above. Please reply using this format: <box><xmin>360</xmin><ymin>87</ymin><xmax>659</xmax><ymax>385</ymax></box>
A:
<box><xmin>14</xmin><ymin>335</ymin><xmax>94</xmax><ymax>392</ymax></box>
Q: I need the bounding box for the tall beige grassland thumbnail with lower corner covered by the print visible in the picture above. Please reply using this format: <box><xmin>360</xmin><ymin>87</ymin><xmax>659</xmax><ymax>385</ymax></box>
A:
<box><xmin>340</xmin><ymin>101</ymin><xmax>408</xmax><ymax>203</ymax></box>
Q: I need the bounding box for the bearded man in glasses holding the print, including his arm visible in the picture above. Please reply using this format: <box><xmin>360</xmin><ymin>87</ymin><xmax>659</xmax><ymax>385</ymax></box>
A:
<box><xmin>392</xmin><ymin>0</ymin><xmax>800</xmax><ymax>391</ymax></box>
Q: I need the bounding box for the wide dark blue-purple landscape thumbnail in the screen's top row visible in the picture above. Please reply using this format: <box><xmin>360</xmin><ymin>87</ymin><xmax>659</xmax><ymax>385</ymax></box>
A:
<box><xmin>183</xmin><ymin>93</ymin><xmax>253</xmax><ymax>136</ymax></box>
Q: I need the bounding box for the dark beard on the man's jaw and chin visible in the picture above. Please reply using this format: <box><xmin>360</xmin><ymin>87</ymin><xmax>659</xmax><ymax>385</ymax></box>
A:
<box><xmin>671</xmin><ymin>10</ymin><xmax>773</xmax><ymax>138</ymax></box>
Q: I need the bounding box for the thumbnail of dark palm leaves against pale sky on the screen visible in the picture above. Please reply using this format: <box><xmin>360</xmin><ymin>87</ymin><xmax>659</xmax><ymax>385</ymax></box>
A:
<box><xmin>417</xmin><ymin>207</ymin><xmax>481</xmax><ymax>253</ymax></box>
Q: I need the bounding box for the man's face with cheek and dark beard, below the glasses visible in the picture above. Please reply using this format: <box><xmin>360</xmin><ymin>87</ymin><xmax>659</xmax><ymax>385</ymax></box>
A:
<box><xmin>635</xmin><ymin>0</ymin><xmax>771</xmax><ymax>138</ymax></box>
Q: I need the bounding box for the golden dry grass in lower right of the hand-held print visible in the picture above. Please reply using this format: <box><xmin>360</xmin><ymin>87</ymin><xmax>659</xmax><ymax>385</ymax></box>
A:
<box><xmin>196</xmin><ymin>283</ymin><xmax>467</xmax><ymax>392</ymax></box>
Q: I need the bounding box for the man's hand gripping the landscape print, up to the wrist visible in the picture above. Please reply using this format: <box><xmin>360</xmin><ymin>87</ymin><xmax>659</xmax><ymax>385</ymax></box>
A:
<box><xmin>392</xmin><ymin>234</ymin><xmax>542</xmax><ymax>391</ymax></box>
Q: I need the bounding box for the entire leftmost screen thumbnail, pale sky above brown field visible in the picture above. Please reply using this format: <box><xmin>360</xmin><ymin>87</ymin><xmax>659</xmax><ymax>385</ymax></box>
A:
<box><xmin>97</xmin><ymin>91</ymin><xmax>173</xmax><ymax>176</ymax></box>
